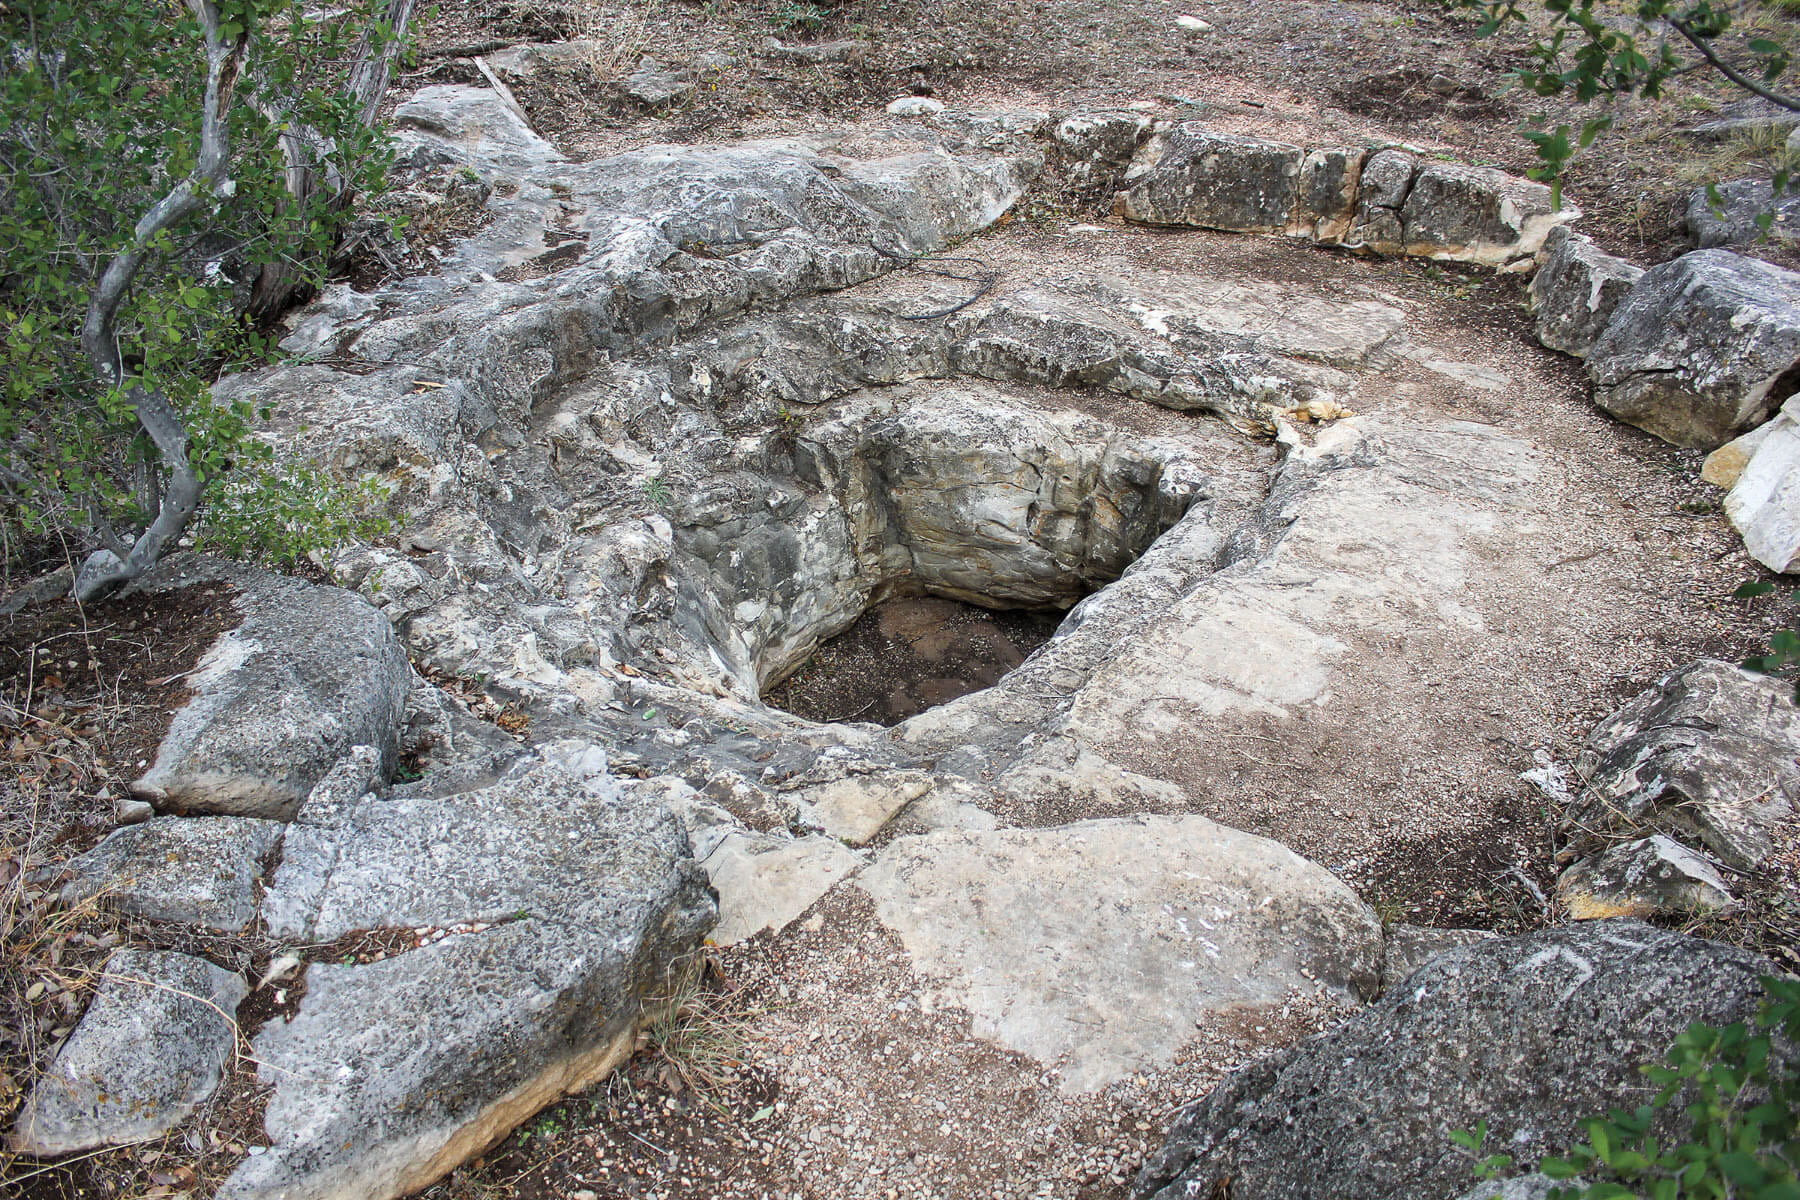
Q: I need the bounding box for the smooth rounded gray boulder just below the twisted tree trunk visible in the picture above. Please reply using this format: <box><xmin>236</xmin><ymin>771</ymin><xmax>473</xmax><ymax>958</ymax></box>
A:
<box><xmin>131</xmin><ymin>560</ymin><xmax>414</xmax><ymax>820</ymax></box>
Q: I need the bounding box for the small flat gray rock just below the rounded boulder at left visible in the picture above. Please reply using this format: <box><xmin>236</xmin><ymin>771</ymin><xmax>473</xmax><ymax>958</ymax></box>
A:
<box><xmin>63</xmin><ymin>817</ymin><xmax>283</xmax><ymax>932</ymax></box>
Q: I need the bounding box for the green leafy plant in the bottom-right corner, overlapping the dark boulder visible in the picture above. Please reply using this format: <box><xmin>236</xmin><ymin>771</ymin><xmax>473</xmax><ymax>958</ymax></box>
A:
<box><xmin>1451</xmin><ymin>975</ymin><xmax>1800</xmax><ymax>1200</ymax></box>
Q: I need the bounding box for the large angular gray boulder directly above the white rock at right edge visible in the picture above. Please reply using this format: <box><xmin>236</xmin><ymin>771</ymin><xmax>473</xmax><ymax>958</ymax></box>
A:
<box><xmin>1588</xmin><ymin>250</ymin><xmax>1800</xmax><ymax>450</ymax></box>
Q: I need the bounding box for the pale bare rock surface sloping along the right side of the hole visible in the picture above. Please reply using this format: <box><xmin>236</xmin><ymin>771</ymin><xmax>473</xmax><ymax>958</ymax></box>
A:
<box><xmin>1067</xmin><ymin>417</ymin><xmax>1539</xmax><ymax>745</ymax></box>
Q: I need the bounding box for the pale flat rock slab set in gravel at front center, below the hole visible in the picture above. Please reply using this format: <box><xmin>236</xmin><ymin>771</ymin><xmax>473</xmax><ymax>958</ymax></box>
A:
<box><xmin>857</xmin><ymin>817</ymin><xmax>1381</xmax><ymax>1090</ymax></box>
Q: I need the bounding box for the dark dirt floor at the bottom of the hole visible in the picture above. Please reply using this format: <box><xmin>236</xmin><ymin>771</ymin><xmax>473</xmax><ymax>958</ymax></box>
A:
<box><xmin>763</xmin><ymin>596</ymin><xmax>1064</xmax><ymax>725</ymax></box>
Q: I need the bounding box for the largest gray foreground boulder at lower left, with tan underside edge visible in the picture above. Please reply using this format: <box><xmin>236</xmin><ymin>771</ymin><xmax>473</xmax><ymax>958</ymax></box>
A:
<box><xmin>230</xmin><ymin>745</ymin><xmax>716</xmax><ymax>1200</ymax></box>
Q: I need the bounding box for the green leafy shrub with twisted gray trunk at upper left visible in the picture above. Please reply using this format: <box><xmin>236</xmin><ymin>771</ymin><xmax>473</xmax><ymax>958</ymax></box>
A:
<box><xmin>0</xmin><ymin>0</ymin><xmax>410</xmax><ymax>590</ymax></box>
